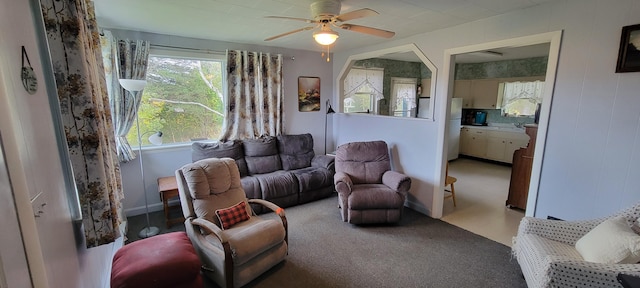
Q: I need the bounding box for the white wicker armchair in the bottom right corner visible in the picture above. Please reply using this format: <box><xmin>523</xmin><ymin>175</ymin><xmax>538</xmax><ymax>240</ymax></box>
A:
<box><xmin>512</xmin><ymin>203</ymin><xmax>640</xmax><ymax>288</ymax></box>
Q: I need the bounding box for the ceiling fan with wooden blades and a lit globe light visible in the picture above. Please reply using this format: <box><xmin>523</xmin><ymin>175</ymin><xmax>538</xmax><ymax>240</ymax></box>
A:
<box><xmin>264</xmin><ymin>0</ymin><xmax>396</xmax><ymax>45</ymax></box>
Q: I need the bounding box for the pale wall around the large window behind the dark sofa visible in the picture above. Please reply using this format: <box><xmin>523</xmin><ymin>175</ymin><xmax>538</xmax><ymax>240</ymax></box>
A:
<box><xmin>111</xmin><ymin>29</ymin><xmax>333</xmax><ymax>216</ymax></box>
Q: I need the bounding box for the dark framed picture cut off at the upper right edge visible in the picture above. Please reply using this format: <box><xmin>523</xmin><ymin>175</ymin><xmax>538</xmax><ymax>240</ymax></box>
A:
<box><xmin>616</xmin><ymin>24</ymin><xmax>640</xmax><ymax>73</ymax></box>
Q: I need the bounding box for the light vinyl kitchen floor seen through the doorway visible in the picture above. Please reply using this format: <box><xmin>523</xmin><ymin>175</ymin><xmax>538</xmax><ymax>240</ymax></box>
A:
<box><xmin>441</xmin><ymin>158</ymin><xmax>524</xmax><ymax>247</ymax></box>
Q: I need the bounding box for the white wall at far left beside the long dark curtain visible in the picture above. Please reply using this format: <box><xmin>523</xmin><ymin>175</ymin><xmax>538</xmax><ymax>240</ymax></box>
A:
<box><xmin>0</xmin><ymin>0</ymin><xmax>122</xmax><ymax>287</ymax></box>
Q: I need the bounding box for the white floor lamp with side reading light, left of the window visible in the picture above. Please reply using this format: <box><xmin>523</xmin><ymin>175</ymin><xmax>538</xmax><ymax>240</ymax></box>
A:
<box><xmin>118</xmin><ymin>79</ymin><xmax>162</xmax><ymax>238</ymax></box>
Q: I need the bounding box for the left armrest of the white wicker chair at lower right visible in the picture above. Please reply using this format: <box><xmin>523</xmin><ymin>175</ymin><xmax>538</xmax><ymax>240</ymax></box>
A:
<box><xmin>516</xmin><ymin>217</ymin><xmax>604</xmax><ymax>245</ymax></box>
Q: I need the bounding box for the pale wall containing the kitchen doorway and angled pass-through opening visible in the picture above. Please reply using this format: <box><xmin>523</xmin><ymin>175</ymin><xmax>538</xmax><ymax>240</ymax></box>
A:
<box><xmin>333</xmin><ymin>0</ymin><xmax>640</xmax><ymax>219</ymax></box>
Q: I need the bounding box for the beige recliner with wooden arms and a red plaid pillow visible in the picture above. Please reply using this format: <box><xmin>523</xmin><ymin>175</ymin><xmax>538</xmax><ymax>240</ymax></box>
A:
<box><xmin>176</xmin><ymin>158</ymin><xmax>287</xmax><ymax>287</ymax></box>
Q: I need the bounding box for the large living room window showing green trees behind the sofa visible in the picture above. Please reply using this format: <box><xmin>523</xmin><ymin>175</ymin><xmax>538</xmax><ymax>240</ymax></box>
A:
<box><xmin>127</xmin><ymin>50</ymin><xmax>226</xmax><ymax>146</ymax></box>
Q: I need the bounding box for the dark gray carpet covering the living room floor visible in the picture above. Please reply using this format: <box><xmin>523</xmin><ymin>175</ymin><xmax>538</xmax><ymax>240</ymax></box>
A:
<box><xmin>128</xmin><ymin>197</ymin><xmax>526</xmax><ymax>287</ymax></box>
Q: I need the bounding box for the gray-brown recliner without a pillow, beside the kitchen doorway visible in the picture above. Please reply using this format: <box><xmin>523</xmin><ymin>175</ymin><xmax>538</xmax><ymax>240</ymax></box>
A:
<box><xmin>334</xmin><ymin>141</ymin><xmax>411</xmax><ymax>224</ymax></box>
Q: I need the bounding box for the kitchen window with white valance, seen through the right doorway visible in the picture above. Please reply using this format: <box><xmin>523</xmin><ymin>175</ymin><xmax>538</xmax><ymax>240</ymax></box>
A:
<box><xmin>502</xmin><ymin>81</ymin><xmax>544</xmax><ymax>117</ymax></box>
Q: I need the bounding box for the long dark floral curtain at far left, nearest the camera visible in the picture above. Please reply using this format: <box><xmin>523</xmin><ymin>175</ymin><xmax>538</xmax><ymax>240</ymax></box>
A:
<box><xmin>40</xmin><ymin>0</ymin><xmax>124</xmax><ymax>247</ymax></box>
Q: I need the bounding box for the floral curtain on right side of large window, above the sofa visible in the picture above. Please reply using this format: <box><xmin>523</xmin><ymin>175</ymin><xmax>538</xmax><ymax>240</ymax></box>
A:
<box><xmin>220</xmin><ymin>50</ymin><xmax>284</xmax><ymax>141</ymax></box>
